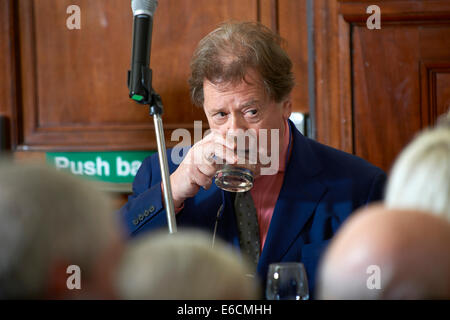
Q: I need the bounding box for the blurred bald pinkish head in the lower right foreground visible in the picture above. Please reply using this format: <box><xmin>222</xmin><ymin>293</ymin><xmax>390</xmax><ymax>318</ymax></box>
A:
<box><xmin>318</xmin><ymin>206</ymin><xmax>450</xmax><ymax>299</ymax></box>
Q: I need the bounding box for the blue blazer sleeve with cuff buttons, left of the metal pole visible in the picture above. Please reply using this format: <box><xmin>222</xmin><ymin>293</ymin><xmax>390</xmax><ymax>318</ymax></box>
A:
<box><xmin>118</xmin><ymin>154</ymin><xmax>167</xmax><ymax>236</ymax></box>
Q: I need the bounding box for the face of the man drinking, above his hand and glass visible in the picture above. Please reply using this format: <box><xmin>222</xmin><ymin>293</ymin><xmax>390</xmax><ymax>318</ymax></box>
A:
<box><xmin>203</xmin><ymin>69</ymin><xmax>291</xmax><ymax>162</ymax></box>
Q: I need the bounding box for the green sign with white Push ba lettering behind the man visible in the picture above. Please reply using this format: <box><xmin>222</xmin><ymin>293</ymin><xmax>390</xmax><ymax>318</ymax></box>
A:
<box><xmin>46</xmin><ymin>151</ymin><xmax>155</xmax><ymax>184</ymax></box>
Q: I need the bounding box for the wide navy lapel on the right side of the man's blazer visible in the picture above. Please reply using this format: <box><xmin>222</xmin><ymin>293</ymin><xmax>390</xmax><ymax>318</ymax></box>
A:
<box><xmin>258</xmin><ymin>124</ymin><xmax>326</xmax><ymax>275</ymax></box>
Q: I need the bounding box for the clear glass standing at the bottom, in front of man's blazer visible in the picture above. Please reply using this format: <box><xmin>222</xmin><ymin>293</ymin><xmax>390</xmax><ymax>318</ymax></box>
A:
<box><xmin>266</xmin><ymin>262</ymin><xmax>309</xmax><ymax>300</ymax></box>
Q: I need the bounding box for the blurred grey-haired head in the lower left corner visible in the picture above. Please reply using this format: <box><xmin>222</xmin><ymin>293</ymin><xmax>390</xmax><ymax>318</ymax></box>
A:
<box><xmin>0</xmin><ymin>160</ymin><xmax>121</xmax><ymax>299</ymax></box>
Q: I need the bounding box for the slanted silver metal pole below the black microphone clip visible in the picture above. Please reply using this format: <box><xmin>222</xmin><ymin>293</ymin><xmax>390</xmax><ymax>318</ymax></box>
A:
<box><xmin>153</xmin><ymin>113</ymin><xmax>177</xmax><ymax>233</ymax></box>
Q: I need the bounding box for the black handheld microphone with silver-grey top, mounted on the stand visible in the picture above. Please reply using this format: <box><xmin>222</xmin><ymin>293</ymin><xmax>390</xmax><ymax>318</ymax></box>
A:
<box><xmin>128</xmin><ymin>0</ymin><xmax>158</xmax><ymax>104</ymax></box>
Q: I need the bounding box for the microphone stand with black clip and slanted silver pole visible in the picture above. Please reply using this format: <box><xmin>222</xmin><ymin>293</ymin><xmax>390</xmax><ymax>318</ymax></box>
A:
<box><xmin>128</xmin><ymin>66</ymin><xmax>177</xmax><ymax>233</ymax></box>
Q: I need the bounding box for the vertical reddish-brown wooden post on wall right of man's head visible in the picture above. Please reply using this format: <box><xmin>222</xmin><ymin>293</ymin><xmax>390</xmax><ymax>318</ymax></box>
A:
<box><xmin>314</xmin><ymin>0</ymin><xmax>353</xmax><ymax>153</ymax></box>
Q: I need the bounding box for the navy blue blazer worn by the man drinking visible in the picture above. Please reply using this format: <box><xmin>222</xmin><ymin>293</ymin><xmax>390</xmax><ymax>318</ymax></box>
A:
<box><xmin>119</xmin><ymin>121</ymin><xmax>386</xmax><ymax>297</ymax></box>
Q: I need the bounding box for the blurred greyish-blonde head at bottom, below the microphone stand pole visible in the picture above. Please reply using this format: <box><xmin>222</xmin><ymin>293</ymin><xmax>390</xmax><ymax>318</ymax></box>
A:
<box><xmin>118</xmin><ymin>229</ymin><xmax>260</xmax><ymax>300</ymax></box>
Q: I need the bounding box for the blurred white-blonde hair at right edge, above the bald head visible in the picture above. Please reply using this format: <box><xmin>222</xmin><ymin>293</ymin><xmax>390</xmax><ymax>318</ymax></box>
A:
<box><xmin>385</xmin><ymin>112</ymin><xmax>450</xmax><ymax>221</ymax></box>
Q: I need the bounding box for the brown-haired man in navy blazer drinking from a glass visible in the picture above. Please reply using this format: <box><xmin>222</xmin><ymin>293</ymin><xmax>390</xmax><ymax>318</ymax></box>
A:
<box><xmin>119</xmin><ymin>22</ymin><xmax>385</xmax><ymax>296</ymax></box>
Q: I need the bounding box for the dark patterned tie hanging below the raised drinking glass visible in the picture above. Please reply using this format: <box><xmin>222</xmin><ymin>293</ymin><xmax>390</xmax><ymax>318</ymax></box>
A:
<box><xmin>234</xmin><ymin>191</ymin><xmax>260</xmax><ymax>271</ymax></box>
